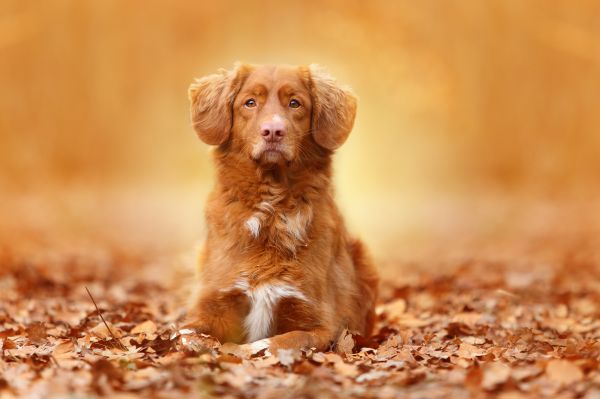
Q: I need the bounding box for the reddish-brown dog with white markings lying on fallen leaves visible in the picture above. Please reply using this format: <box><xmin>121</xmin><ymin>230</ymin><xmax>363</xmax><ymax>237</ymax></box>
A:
<box><xmin>188</xmin><ymin>64</ymin><xmax>378</xmax><ymax>354</ymax></box>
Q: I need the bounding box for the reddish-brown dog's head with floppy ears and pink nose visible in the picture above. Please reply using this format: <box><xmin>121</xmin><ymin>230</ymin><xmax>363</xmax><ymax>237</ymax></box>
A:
<box><xmin>189</xmin><ymin>64</ymin><xmax>356</xmax><ymax>164</ymax></box>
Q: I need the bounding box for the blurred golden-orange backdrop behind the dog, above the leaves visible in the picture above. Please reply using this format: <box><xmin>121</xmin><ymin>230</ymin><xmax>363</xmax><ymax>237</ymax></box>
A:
<box><xmin>0</xmin><ymin>0</ymin><xmax>600</xmax><ymax>265</ymax></box>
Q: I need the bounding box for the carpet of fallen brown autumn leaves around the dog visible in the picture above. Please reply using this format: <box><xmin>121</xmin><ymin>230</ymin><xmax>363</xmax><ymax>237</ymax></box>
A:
<box><xmin>0</xmin><ymin>248</ymin><xmax>600</xmax><ymax>399</ymax></box>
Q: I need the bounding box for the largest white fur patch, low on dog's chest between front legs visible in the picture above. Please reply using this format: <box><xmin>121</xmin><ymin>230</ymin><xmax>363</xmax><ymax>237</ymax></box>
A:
<box><xmin>230</xmin><ymin>280</ymin><xmax>308</xmax><ymax>342</ymax></box>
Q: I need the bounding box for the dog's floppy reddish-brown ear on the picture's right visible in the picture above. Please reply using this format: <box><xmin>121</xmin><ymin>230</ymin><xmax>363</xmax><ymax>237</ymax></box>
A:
<box><xmin>308</xmin><ymin>65</ymin><xmax>356</xmax><ymax>150</ymax></box>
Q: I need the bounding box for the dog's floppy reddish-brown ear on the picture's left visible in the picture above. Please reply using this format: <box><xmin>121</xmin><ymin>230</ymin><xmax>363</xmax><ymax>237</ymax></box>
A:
<box><xmin>188</xmin><ymin>64</ymin><xmax>249</xmax><ymax>145</ymax></box>
